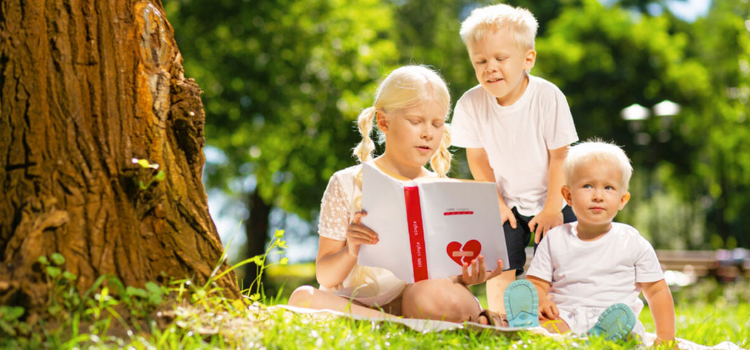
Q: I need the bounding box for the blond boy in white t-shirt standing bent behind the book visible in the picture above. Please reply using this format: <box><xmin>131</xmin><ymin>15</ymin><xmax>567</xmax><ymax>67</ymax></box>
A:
<box><xmin>452</xmin><ymin>4</ymin><xmax>578</xmax><ymax>314</ymax></box>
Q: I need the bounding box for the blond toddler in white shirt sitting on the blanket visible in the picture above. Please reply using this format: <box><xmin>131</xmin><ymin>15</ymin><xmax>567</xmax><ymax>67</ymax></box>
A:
<box><xmin>526</xmin><ymin>141</ymin><xmax>675</xmax><ymax>342</ymax></box>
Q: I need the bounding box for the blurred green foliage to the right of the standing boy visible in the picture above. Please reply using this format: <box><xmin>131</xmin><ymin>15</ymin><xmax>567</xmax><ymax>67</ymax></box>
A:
<box><xmin>535</xmin><ymin>0</ymin><xmax>750</xmax><ymax>248</ymax></box>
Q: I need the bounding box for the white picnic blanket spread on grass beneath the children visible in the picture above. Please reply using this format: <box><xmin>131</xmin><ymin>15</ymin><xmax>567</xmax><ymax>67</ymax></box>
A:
<box><xmin>268</xmin><ymin>305</ymin><xmax>743</xmax><ymax>350</ymax></box>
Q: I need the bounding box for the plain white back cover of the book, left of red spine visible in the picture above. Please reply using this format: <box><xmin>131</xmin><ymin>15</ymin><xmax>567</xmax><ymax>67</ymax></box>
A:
<box><xmin>357</xmin><ymin>163</ymin><xmax>414</xmax><ymax>283</ymax></box>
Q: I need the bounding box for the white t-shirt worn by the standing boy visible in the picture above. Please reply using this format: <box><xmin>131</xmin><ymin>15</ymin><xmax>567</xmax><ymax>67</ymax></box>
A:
<box><xmin>451</xmin><ymin>75</ymin><xmax>578</xmax><ymax>216</ymax></box>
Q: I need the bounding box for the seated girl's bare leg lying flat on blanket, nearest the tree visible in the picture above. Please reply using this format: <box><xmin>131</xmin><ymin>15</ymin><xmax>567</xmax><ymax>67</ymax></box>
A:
<box><xmin>288</xmin><ymin>286</ymin><xmax>394</xmax><ymax>318</ymax></box>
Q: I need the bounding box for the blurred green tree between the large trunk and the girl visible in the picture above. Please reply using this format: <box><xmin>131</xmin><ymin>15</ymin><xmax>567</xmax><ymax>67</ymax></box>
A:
<box><xmin>166</xmin><ymin>0</ymin><xmax>397</xmax><ymax>287</ymax></box>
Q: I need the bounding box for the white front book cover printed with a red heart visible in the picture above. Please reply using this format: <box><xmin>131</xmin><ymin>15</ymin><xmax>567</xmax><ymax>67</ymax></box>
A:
<box><xmin>419</xmin><ymin>181</ymin><xmax>509</xmax><ymax>278</ymax></box>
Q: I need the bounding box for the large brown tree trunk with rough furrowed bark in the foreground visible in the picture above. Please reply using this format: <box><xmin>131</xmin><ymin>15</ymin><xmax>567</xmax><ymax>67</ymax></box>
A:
<box><xmin>0</xmin><ymin>0</ymin><xmax>239</xmax><ymax>310</ymax></box>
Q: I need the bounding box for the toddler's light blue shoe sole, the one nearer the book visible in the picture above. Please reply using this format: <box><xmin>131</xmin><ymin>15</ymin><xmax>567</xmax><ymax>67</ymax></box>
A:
<box><xmin>503</xmin><ymin>280</ymin><xmax>539</xmax><ymax>327</ymax></box>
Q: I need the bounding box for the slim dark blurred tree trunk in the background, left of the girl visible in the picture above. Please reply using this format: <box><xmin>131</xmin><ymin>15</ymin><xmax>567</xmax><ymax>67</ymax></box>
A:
<box><xmin>242</xmin><ymin>187</ymin><xmax>271</xmax><ymax>291</ymax></box>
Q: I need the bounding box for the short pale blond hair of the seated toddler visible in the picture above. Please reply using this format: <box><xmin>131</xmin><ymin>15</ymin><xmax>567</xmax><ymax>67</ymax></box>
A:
<box><xmin>563</xmin><ymin>139</ymin><xmax>633</xmax><ymax>191</ymax></box>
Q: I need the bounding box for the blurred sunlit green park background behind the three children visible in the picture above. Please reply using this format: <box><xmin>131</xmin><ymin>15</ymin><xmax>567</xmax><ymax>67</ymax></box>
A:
<box><xmin>163</xmin><ymin>0</ymin><xmax>750</xmax><ymax>334</ymax></box>
